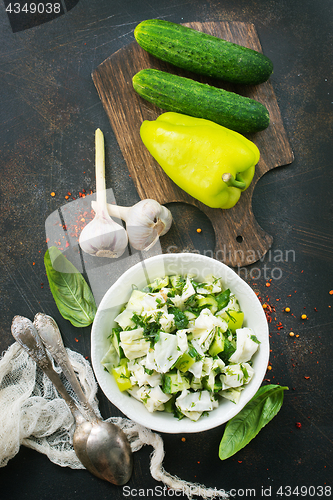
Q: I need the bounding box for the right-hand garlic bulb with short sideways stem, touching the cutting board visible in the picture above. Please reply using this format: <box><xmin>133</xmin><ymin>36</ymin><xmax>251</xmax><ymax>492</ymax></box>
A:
<box><xmin>92</xmin><ymin>199</ymin><xmax>172</xmax><ymax>250</ymax></box>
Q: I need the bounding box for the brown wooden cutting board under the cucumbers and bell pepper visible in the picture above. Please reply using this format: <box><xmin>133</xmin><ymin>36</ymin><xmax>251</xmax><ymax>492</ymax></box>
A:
<box><xmin>92</xmin><ymin>22</ymin><xmax>293</xmax><ymax>266</ymax></box>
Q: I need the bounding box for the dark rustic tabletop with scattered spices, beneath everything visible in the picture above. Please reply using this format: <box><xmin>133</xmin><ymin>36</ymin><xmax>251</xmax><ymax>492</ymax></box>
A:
<box><xmin>0</xmin><ymin>0</ymin><xmax>333</xmax><ymax>500</ymax></box>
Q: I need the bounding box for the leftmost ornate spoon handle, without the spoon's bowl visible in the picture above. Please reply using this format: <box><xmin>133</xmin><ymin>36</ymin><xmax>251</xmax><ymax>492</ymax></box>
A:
<box><xmin>11</xmin><ymin>316</ymin><xmax>83</xmax><ymax>422</ymax></box>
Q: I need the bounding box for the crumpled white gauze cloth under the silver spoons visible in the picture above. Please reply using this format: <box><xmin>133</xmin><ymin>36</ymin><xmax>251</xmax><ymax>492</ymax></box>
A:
<box><xmin>0</xmin><ymin>342</ymin><xmax>229</xmax><ymax>499</ymax></box>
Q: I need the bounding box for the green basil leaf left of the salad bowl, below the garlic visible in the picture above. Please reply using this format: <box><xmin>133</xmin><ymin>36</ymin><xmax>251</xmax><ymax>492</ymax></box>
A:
<box><xmin>44</xmin><ymin>246</ymin><xmax>97</xmax><ymax>327</ymax></box>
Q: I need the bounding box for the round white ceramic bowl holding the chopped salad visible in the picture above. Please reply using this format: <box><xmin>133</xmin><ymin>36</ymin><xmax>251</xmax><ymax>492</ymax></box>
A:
<box><xmin>91</xmin><ymin>253</ymin><xmax>269</xmax><ymax>434</ymax></box>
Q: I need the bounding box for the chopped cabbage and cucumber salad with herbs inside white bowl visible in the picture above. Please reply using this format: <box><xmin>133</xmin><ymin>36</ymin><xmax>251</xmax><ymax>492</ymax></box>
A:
<box><xmin>101</xmin><ymin>275</ymin><xmax>260</xmax><ymax>421</ymax></box>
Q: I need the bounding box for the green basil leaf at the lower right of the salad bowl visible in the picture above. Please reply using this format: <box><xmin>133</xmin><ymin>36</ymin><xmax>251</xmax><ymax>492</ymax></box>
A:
<box><xmin>219</xmin><ymin>384</ymin><xmax>288</xmax><ymax>460</ymax></box>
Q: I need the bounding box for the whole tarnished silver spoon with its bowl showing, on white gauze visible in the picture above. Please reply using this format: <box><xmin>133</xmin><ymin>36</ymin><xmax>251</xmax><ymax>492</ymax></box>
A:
<box><xmin>12</xmin><ymin>316</ymin><xmax>133</xmax><ymax>485</ymax></box>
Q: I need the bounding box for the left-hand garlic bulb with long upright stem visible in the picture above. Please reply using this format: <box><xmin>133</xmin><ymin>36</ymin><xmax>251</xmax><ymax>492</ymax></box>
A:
<box><xmin>79</xmin><ymin>129</ymin><xmax>128</xmax><ymax>258</ymax></box>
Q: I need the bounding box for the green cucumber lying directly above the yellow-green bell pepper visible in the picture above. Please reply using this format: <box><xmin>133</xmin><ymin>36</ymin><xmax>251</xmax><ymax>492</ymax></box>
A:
<box><xmin>133</xmin><ymin>69</ymin><xmax>269</xmax><ymax>134</ymax></box>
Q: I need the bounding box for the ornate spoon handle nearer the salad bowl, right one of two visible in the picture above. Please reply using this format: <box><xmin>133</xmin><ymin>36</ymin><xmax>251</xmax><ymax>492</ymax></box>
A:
<box><xmin>33</xmin><ymin>313</ymin><xmax>97</xmax><ymax>421</ymax></box>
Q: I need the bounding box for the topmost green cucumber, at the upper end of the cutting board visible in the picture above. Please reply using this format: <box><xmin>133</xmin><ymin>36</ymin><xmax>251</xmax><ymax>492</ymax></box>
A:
<box><xmin>134</xmin><ymin>19</ymin><xmax>273</xmax><ymax>85</ymax></box>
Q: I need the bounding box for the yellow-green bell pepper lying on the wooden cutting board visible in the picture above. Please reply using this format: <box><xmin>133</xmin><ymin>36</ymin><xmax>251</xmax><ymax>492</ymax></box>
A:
<box><xmin>140</xmin><ymin>112</ymin><xmax>260</xmax><ymax>208</ymax></box>
